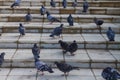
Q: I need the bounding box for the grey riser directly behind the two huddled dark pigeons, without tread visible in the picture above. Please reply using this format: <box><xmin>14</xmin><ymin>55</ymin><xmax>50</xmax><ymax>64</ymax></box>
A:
<box><xmin>0</xmin><ymin>42</ymin><xmax>120</xmax><ymax>50</ymax></box>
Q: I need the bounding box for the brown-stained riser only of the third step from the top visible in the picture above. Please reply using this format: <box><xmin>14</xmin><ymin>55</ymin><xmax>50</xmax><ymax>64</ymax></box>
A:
<box><xmin>0</xmin><ymin>16</ymin><xmax>120</xmax><ymax>23</ymax></box>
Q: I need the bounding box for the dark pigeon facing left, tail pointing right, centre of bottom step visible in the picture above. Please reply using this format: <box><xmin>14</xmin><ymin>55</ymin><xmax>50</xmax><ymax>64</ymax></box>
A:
<box><xmin>54</xmin><ymin>61</ymin><xmax>79</xmax><ymax>76</ymax></box>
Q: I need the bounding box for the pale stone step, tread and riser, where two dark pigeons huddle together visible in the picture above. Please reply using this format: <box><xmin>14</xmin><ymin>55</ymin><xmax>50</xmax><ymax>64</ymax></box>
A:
<box><xmin>0</xmin><ymin>49</ymin><xmax>120</xmax><ymax>69</ymax></box>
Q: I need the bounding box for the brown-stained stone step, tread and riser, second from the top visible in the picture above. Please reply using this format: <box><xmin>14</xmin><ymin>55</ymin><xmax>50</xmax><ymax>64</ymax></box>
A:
<box><xmin>0</xmin><ymin>6</ymin><xmax>120</xmax><ymax>15</ymax></box>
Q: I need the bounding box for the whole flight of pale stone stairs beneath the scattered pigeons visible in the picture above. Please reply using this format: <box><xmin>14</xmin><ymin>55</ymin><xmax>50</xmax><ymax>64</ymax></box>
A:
<box><xmin>0</xmin><ymin>0</ymin><xmax>120</xmax><ymax>75</ymax></box>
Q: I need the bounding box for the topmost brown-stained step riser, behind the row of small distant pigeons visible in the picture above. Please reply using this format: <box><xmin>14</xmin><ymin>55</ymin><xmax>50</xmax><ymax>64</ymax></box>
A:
<box><xmin>0</xmin><ymin>0</ymin><xmax>120</xmax><ymax>7</ymax></box>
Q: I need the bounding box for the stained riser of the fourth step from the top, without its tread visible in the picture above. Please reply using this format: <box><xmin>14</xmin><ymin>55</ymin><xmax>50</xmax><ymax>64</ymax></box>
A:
<box><xmin>0</xmin><ymin>28</ymin><xmax>120</xmax><ymax>34</ymax></box>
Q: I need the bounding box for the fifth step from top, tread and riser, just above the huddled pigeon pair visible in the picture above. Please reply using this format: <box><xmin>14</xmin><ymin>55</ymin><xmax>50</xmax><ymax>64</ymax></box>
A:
<box><xmin>0</xmin><ymin>33</ymin><xmax>120</xmax><ymax>50</ymax></box>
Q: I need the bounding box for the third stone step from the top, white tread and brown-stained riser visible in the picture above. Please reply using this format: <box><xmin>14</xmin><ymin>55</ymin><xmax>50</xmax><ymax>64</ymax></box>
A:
<box><xmin>0</xmin><ymin>14</ymin><xmax>120</xmax><ymax>23</ymax></box>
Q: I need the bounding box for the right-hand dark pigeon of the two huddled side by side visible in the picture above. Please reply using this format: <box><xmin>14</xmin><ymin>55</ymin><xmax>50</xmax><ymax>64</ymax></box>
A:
<box><xmin>64</xmin><ymin>40</ymin><xmax>78</xmax><ymax>56</ymax></box>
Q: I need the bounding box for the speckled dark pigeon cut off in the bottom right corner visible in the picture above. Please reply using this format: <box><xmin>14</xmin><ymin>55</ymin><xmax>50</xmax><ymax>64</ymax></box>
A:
<box><xmin>101</xmin><ymin>67</ymin><xmax>120</xmax><ymax>80</ymax></box>
